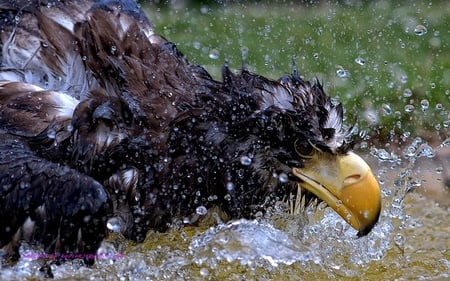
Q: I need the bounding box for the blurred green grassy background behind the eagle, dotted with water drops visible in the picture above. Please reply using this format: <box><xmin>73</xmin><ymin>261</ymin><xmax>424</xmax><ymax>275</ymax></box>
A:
<box><xmin>142</xmin><ymin>1</ymin><xmax>450</xmax><ymax>143</ymax></box>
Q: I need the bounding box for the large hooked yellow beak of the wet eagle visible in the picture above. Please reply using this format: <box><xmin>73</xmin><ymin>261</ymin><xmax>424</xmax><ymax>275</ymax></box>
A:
<box><xmin>293</xmin><ymin>152</ymin><xmax>381</xmax><ymax>236</ymax></box>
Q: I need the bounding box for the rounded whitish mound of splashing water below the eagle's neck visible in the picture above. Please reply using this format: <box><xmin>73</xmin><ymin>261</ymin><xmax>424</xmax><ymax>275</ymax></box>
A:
<box><xmin>189</xmin><ymin>219</ymin><xmax>321</xmax><ymax>268</ymax></box>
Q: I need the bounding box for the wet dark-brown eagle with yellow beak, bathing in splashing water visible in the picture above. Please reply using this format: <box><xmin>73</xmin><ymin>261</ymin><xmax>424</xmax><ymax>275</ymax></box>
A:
<box><xmin>0</xmin><ymin>0</ymin><xmax>381</xmax><ymax>262</ymax></box>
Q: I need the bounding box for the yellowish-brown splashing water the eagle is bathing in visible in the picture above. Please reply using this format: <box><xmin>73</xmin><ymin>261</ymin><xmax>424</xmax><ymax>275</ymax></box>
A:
<box><xmin>0</xmin><ymin>138</ymin><xmax>450</xmax><ymax>280</ymax></box>
